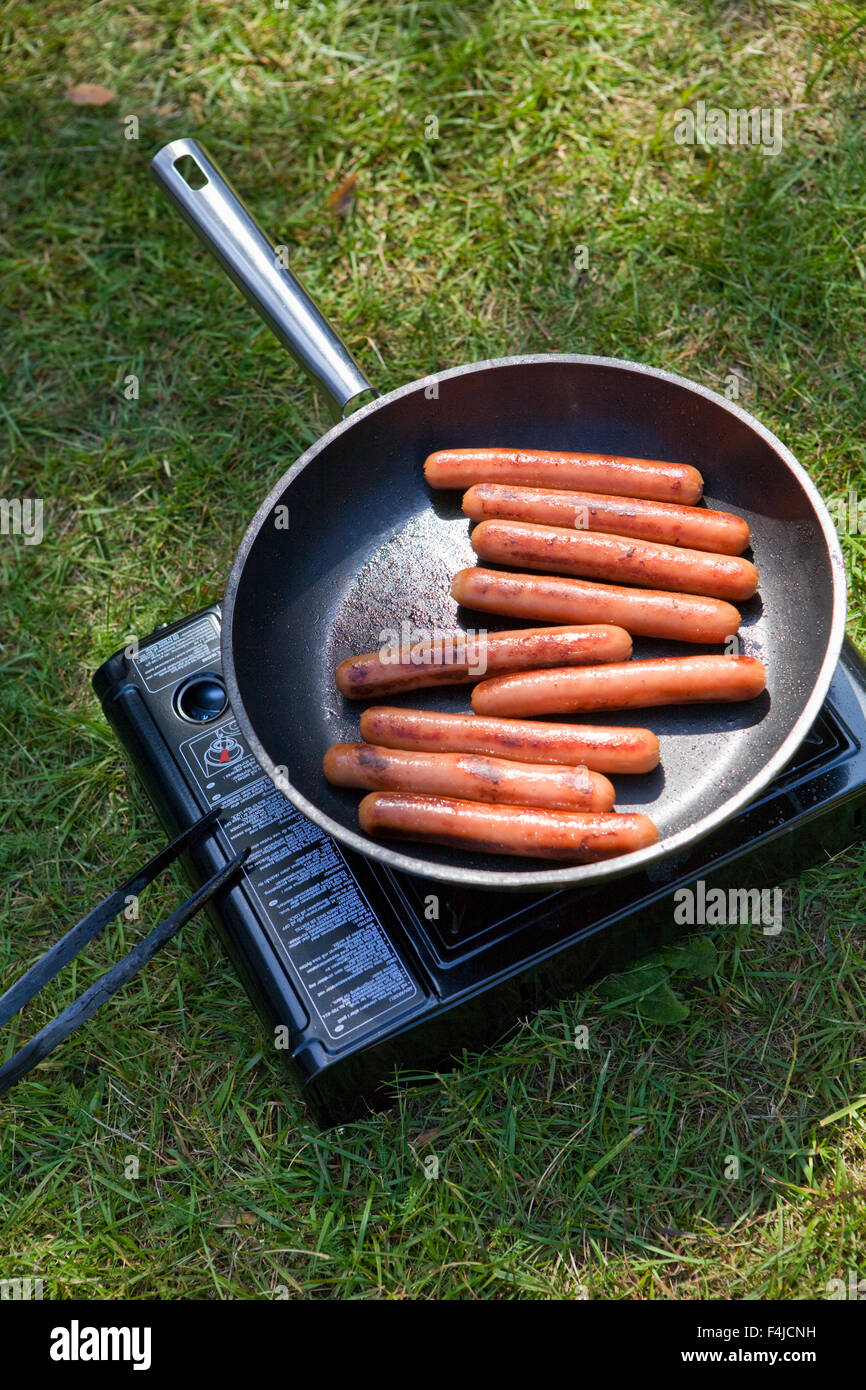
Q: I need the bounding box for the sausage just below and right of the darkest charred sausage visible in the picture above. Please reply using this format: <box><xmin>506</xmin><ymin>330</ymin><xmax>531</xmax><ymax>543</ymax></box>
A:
<box><xmin>473</xmin><ymin>656</ymin><xmax>766</xmax><ymax>716</ymax></box>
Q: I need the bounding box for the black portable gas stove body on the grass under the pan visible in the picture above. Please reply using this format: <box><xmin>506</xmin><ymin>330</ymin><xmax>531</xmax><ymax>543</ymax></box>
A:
<box><xmin>93</xmin><ymin>605</ymin><xmax>866</xmax><ymax>1123</ymax></box>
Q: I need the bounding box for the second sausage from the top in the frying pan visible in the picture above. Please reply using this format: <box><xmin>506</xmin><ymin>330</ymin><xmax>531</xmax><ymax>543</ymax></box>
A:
<box><xmin>463</xmin><ymin>482</ymin><xmax>751</xmax><ymax>555</ymax></box>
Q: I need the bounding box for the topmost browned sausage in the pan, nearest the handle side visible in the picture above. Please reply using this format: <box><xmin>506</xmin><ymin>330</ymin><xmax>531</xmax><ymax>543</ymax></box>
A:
<box><xmin>424</xmin><ymin>449</ymin><xmax>703</xmax><ymax>505</ymax></box>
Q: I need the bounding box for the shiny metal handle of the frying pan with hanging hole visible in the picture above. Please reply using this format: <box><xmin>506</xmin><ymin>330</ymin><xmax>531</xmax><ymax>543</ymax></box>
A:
<box><xmin>150</xmin><ymin>139</ymin><xmax>373</xmax><ymax>416</ymax></box>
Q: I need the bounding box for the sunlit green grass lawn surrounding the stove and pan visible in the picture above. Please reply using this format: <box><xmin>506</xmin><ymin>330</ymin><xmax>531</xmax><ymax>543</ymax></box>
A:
<box><xmin>0</xmin><ymin>0</ymin><xmax>866</xmax><ymax>1298</ymax></box>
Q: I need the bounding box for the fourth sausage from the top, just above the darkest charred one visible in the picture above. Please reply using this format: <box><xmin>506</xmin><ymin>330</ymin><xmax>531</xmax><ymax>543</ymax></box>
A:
<box><xmin>450</xmin><ymin>569</ymin><xmax>740</xmax><ymax>642</ymax></box>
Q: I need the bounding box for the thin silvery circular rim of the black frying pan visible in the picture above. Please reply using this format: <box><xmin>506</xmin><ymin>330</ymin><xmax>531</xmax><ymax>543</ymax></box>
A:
<box><xmin>221</xmin><ymin>353</ymin><xmax>847</xmax><ymax>892</ymax></box>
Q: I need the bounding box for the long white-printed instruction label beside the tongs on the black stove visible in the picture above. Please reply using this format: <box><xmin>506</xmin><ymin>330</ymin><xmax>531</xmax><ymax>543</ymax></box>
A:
<box><xmin>181</xmin><ymin>717</ymin><xmax>420</xmax><ymax>1041</ymax></box>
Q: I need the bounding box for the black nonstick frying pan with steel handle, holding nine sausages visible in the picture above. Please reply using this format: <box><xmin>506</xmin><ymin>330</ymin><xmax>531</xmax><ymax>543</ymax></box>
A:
<box><xmin>153</xmin><ymin>139</ymin><xmax>845</xmax><ymax>892</ymax></box>
